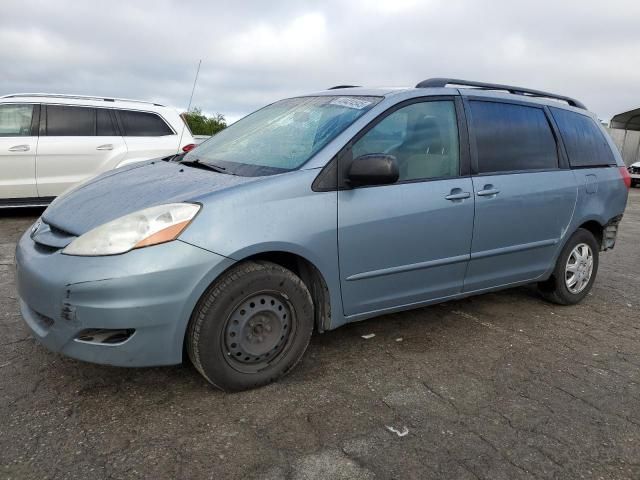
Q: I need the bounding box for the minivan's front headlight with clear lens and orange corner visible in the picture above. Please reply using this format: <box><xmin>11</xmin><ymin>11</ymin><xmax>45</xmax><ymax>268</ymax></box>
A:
<box><xmin>62</xmin><ymin>203</ymin><xmax>200</xmax><ymax>256</ymax></box>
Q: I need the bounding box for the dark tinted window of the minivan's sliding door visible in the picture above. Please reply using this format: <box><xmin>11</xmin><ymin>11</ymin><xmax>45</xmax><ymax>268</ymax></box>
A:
<box><xmin>469</xmin><ymin>101</ymin><xmax>558</xmax><ymax>173</ymax></box>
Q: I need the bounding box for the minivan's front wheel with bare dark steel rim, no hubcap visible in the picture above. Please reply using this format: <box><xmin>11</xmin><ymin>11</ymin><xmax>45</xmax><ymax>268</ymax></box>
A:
<box><xmin>186</xmin><ymin>261</ymin><xmax>314</xmax><ymax>392</ymax></box>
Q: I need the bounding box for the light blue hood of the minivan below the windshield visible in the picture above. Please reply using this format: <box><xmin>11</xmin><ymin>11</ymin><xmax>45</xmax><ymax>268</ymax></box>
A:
<box><xmin>42</xmin><ymin>160</ymin><xmax>260</xmax><ymax>236</ymax></box>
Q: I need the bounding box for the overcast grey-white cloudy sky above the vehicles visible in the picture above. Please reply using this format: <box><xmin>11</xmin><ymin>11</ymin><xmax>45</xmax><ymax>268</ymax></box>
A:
<box><xmin>0</xmin><ymin>0</ymin><xmax>640</xmax><ymax>120</ymax></box>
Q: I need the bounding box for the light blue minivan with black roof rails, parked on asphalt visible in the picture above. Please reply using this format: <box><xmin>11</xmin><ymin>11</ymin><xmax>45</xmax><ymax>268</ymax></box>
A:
<box><xmin>16</xmin><ymin>78</ymin><xmax>630</xmax><ymax>391</ymax></box>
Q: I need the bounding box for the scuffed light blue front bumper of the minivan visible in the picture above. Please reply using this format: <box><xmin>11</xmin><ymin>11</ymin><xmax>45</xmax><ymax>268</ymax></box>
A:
<box><xmin>16</xmin><ymin>233</ymin><xmax>233</xmax><ymax>367</ymax></box>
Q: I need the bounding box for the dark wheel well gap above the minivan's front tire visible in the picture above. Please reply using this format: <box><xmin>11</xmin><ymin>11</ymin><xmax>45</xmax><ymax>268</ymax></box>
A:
<box><xmin>243</xmin><ymin>252</ymin><xmax>331</xmax><ymax>332</ymax></box>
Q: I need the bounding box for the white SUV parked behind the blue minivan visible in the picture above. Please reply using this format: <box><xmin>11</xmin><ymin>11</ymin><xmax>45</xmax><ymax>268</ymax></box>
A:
<box><xmin>0</xmin><ymin>93</ymin><xmax>196</xmax><ymax>207</ymax></box>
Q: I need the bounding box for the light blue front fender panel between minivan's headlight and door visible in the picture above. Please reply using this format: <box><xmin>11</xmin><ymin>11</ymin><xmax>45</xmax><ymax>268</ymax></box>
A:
<box><xmin>180</xmin><ymin>170</ymin><xmax>343</xmax><ymax>327</ymax></box>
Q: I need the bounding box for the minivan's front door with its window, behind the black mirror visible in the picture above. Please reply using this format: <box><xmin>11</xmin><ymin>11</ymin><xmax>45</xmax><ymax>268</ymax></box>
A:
<box><xmin>338</xmin><ymin>97</ymin><xmax>474</xmax><ymax>316</ymax></box>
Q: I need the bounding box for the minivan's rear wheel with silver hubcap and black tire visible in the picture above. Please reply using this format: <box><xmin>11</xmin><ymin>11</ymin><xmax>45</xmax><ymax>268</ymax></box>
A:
<box><xmin>538</xmin><ymin>228</ymin><xmax>600</xmax><ymax>305</ymax></box>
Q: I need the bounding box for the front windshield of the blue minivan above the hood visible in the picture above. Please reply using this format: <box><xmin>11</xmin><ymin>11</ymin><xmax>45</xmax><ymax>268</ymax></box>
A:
<box><xmin>184</xmin><ymin>96</ymin><xmax>381</xmax><ymax>176</ymax></box>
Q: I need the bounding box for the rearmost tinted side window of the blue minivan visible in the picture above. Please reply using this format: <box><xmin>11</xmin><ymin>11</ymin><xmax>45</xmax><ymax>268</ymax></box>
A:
<box><xmin>551</xmin><ymin>107</ymin><xmax>616</xmax><ymax>167</ymax></box>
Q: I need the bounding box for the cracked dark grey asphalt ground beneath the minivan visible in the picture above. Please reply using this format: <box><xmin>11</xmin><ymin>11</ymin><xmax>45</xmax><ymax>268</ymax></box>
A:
<box><xmin>0</xmin><ymin>189</ymin><xmax>640</xmax><ymax>480</ymax></box>
